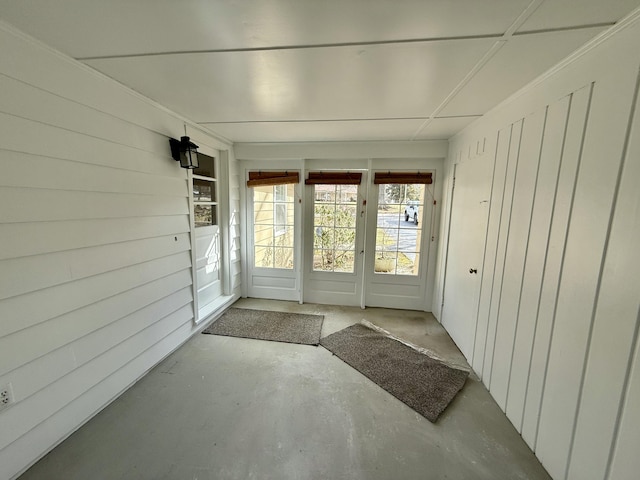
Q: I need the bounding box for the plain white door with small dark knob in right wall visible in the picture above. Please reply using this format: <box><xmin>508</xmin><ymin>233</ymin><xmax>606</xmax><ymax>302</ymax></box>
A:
<box><xmin>442</xmin><ymin>155</ymin><xmax>493</xmax><ymax>359</ymax></box>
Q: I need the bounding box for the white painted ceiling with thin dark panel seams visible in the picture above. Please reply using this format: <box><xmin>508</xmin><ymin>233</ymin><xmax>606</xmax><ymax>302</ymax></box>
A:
<box><xmin>0</xmin><ymin>0</ymin><xmax>640</xmax><ymax>142</ymax></box>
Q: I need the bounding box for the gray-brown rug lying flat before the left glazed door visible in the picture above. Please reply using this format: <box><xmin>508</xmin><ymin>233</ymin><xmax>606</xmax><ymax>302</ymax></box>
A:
<box><xmin>202</xmin><ymin>308</ymin><xmax>324</xmax><ymax>345</ymax></box>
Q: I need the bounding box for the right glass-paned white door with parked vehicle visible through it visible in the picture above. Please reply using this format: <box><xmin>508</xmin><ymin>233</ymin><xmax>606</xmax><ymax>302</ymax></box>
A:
<box><xmin>364</xmin><ymin>183</ymin><xmax>434</xmax><ymax>310</ymax></box>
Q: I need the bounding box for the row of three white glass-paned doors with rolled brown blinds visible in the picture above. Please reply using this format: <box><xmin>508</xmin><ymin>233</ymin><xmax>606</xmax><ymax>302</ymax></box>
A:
<box><xmin>245</xmin><ymin>165</ymin><xmax>434</xmax><ymax>310</ymax></box>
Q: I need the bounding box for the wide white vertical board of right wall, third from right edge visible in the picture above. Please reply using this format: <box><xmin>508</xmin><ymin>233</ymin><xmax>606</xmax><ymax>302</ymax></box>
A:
<box><xmin>536</xmin><ymin>67</ymin><xmax>636</xmax><ymax>475</ymax></box>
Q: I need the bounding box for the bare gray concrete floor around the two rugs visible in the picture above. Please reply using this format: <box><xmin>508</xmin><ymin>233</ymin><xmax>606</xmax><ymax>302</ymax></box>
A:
<box><xmin>20</xmin><ymin>299</ymin><xmax>550</xmax><ymax>480</ymax></box>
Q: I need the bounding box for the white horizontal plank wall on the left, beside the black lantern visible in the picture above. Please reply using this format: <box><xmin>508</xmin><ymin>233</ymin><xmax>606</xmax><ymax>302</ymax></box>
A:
<box><xmin>0</xmin><ymin>23</ymin><xmax>234</xmax><ymax>478</ymax></box>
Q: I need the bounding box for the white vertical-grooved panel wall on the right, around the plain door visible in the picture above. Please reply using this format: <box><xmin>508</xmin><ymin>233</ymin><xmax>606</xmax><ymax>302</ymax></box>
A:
<box><xmin>436</xmin><ymin>14</ymin><xmax>640</xmax><ymax>480</ymax></box>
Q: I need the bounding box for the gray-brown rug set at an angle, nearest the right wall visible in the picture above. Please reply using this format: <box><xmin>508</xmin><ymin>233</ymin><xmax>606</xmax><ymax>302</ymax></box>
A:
<box><xmin>320</xmin><ymin>324</ymin><xmax>468</xmax><ymax>422</ymax></box>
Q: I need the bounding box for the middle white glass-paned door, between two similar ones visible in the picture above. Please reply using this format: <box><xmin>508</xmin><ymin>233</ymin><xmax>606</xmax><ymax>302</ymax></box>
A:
<box><xmin>304</xmin><ymin>175</ymin><xmax>366</xmax><ymax>306</ymax></box>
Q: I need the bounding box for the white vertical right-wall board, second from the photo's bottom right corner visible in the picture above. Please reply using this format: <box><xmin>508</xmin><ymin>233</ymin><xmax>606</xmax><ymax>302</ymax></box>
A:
<box><xmin>567</xmin><ymin>64</ymin><xmax>640</xmax><ymax>479</ymax></box>
